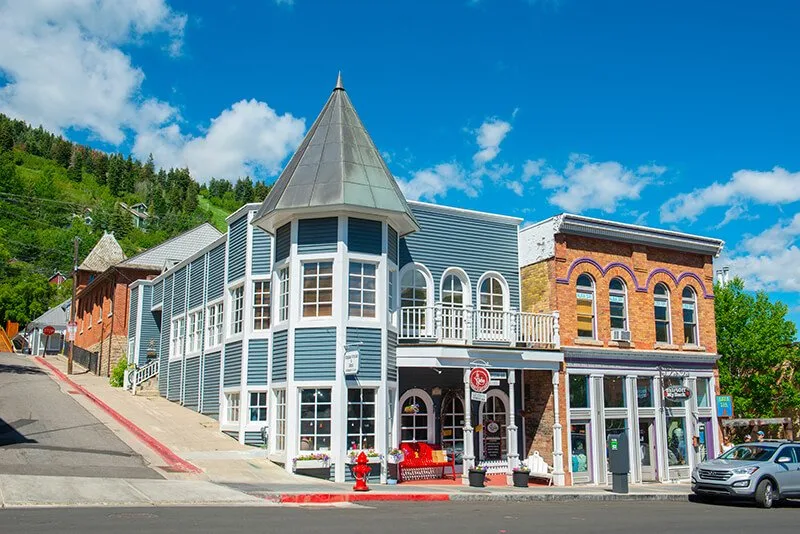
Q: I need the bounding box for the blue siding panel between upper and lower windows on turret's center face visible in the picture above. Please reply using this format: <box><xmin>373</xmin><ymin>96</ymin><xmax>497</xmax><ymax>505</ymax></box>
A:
<box><xmin>294</xmin><ymin>328</ymin><xmax>336</xmax><ymax>380</ymax></box>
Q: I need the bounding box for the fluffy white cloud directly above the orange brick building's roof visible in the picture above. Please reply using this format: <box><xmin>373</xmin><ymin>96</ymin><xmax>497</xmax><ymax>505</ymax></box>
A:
<box><xmin>540</xmin><ymin>154</ymin><xmax>666</xmax><ymax>213</ymax></box>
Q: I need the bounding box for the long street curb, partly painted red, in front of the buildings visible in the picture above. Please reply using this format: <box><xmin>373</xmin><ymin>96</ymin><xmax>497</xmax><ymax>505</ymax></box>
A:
<box><xmin>260</xmin><ymin>493</ymin><xmax>689</xmax><ymax>504</ymax></box>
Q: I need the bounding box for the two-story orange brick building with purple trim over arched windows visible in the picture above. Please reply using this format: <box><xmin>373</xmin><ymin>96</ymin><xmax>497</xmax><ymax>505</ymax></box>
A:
<box><xmin>520</xmin><ymin>214</ymin><xmax>723</xmax><ymax>484</ymax></box>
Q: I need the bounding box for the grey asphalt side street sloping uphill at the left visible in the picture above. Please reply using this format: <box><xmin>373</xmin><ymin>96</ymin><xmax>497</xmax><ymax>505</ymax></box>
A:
<box><xmin>0</xmin><ymin>353</ymin><xmax>162</xmax><ymax>482</ymax></box>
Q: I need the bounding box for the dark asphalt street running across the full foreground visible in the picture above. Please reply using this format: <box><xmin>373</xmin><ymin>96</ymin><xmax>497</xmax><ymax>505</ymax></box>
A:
<box><xmin>0</xmin><ymin>502</ymin><xmax>800</xmax><ymax>534</ymax></box>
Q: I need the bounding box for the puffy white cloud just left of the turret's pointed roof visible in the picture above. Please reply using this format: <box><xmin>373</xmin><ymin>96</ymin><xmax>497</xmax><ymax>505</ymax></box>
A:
<box><xmin>133</xmin><ymin>100</ymin><xmax>305</xmax><ymax>181</ymax></box>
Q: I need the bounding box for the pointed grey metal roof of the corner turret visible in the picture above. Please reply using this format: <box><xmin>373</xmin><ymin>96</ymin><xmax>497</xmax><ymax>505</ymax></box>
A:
<box><xmin>256</xmin><ymin>74</ymin><xmax>419</xmax><ymax>234</ymax></box>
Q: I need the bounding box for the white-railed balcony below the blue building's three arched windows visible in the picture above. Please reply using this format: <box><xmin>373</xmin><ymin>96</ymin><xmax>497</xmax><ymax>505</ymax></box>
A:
<box><xmin>399</xmin><ymin>304</ymin><xmax>561</xmax><ymax>349</ymax></box>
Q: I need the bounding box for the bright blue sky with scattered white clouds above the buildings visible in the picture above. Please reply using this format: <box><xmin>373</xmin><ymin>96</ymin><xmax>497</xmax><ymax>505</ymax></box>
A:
<box><xmin>0</xmin><ymin>0</ymin><xmax>800</xmax><ymax>330</ymax></box>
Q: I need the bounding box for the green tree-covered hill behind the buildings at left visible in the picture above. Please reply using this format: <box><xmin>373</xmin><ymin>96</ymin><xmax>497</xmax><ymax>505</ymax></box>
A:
<box><xmin>0</xmin><ymin>114</ymin><xmax>269</xmax><ymax>324</ymax></box>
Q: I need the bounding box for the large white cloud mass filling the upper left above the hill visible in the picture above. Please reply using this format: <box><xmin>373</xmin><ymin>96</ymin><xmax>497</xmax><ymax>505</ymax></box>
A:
<box><xmin>0</xmin><ymin>0</ymin><xmax>305</xmax><ymax>181</ymax></box>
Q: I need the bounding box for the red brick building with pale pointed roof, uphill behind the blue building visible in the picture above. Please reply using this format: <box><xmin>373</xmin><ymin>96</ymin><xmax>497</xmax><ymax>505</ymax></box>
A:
<box><xmin>75</xmin><ymin>224</ymin><xmax>222</xmax><ymax>376</ymax></box>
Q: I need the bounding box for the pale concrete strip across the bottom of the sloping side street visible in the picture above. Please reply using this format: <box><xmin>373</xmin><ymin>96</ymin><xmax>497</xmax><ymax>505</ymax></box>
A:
<box><xmin>0</xmin><ymin>475</ymin><xmax>269</xmax><ymax>508</ymax></box>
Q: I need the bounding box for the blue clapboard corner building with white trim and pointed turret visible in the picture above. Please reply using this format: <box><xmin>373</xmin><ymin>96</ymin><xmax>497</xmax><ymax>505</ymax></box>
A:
<box><xmin>129</xmin><ymin>79</ymin><xmax>563</xmax><ymax>481</ymax></box>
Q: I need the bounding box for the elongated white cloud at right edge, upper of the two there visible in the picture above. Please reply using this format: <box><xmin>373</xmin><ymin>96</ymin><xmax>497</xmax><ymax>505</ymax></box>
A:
<box><xmin>661</xmin><ymin>167</ymin><xmax>800</xmax><ymax>222</ymax></box>
